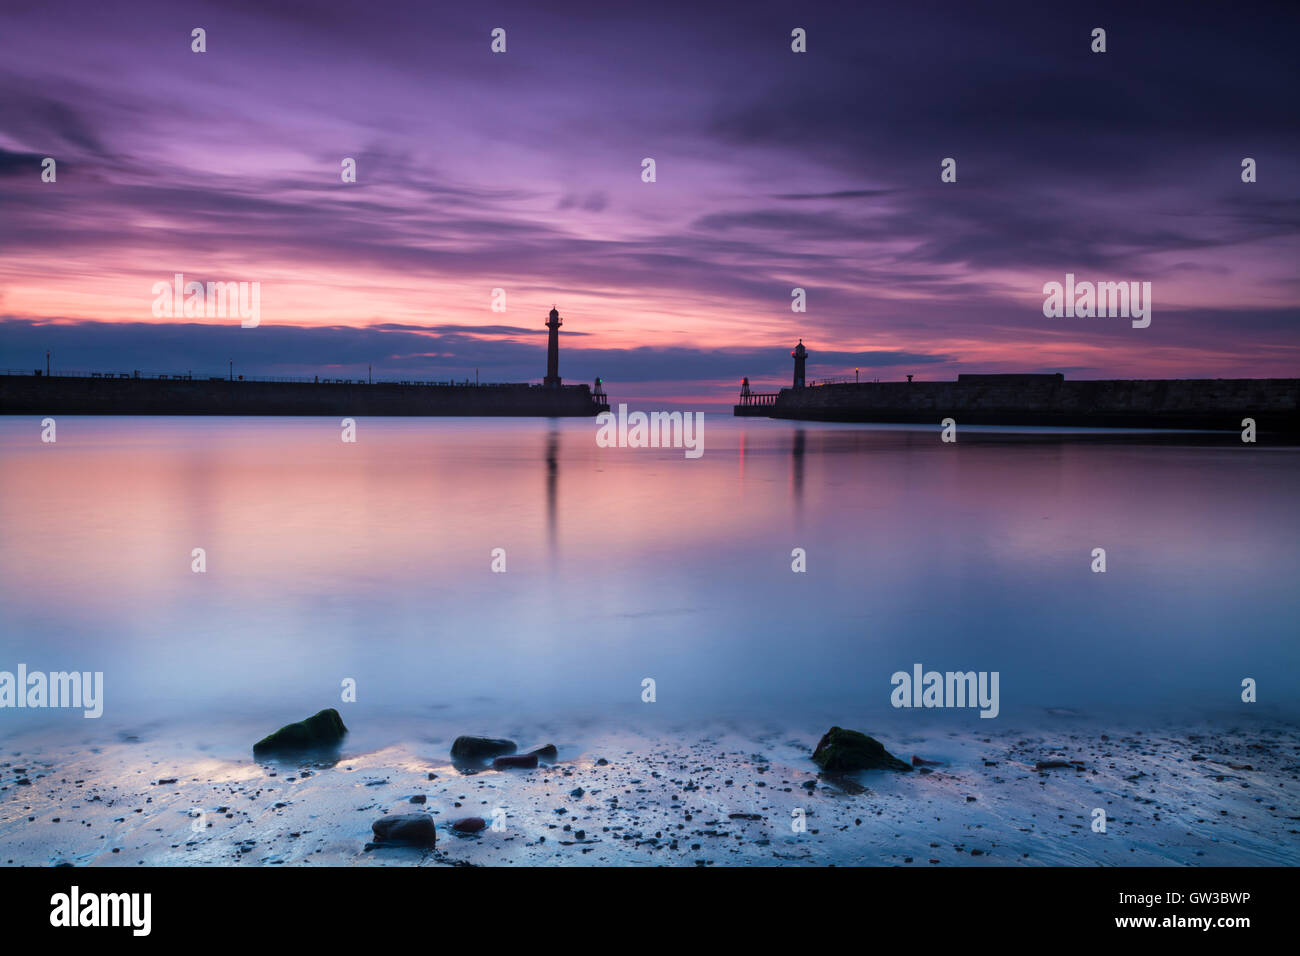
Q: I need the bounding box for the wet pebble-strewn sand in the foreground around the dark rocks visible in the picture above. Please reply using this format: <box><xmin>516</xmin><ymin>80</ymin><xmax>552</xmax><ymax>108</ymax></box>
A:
<box><xmin>0</xmin><ymin>717</ymin><xmax>1300</xmax><ymax>866</ymax></box>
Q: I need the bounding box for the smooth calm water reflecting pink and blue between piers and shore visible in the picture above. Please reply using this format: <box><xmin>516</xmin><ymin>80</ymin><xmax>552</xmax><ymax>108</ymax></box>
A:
<box><xmin>0</xmin><ymin>415</ymin><xmax>1300</xmax><ymax>732</ymax></box>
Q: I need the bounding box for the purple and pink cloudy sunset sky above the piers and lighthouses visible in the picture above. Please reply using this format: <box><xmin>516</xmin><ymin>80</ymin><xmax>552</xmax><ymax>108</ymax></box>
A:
<box><xmin>0</xmin><ymin>0</ymin><xmax>1300</xmax><ymax>403</ymax></box>
